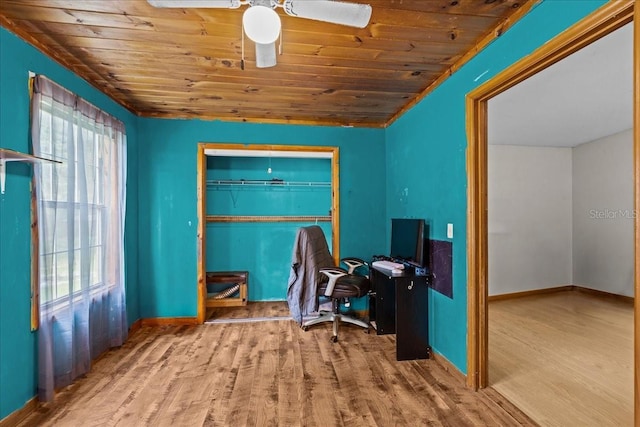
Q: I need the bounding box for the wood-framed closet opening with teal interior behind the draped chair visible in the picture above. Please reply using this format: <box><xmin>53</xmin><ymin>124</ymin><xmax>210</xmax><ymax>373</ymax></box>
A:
<box><xmin>197</xmin><ymin>143</ymin><xmax>340</xmax><ymax>323</ymax></box>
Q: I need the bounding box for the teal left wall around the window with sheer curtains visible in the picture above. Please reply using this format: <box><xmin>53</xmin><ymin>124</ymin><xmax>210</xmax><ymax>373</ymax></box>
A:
<box><xmin>0</xmin><ymin>28</ymin><xmax>140</xmax><ymax>419</ymax></box>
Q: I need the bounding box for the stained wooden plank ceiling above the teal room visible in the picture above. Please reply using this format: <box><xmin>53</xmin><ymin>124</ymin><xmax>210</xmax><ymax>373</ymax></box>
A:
<box><xmin>0</xmin><ymin>0</ymin><xmax>532</xmax><ymax>127</ymax></box>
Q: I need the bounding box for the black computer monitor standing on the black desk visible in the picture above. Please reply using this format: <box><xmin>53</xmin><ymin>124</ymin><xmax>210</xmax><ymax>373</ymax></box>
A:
<box><xmin>390</xmin><ymin>218</ymin><xmax>427</xmax><ymax>267</ymax></box>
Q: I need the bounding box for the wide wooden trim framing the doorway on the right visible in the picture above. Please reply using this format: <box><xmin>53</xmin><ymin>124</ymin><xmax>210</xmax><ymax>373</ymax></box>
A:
<box><xmin>466</xmin><ymin>1</ymin><xmax>640</xmax><ymax>412</ymax></box>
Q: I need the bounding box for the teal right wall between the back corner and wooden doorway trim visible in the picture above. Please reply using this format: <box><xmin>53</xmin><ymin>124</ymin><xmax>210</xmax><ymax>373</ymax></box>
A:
<box><xmin>386</xmin><ymin>0</ymin><xmax>604</xmax><ymax>372</ymax></box>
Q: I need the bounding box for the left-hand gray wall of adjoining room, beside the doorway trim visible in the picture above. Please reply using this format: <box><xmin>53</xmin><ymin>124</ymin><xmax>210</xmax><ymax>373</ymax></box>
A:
<box><xmin>488</xmin><ymin>145</ymin><xmax>572</xmax><ymax>295</ymax></box>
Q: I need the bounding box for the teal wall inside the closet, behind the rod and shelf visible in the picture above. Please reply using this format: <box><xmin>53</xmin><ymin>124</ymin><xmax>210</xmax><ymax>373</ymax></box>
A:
<box><xmin>206</xmin><ymin>157</ymin><xmax>332</xmax><ymax>301</ymax></box>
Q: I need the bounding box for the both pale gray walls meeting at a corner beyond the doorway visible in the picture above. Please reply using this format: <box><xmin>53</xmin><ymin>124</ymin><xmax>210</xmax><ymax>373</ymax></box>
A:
<box><xmin>488</xmin><ymin>129</ymin><xmax>634</xmax><ymax>296</ymax></box>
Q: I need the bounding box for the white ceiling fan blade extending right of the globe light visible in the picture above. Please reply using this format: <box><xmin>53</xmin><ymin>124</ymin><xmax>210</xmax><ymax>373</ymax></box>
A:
<box><xmin>282</xmin><ymin>0</ymin><xmax>371</xmax><ymax>28</ymax></box>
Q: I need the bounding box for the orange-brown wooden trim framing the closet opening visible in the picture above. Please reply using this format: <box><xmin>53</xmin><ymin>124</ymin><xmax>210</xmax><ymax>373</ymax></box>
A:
<box><xmin>196</xmin><ymin>142</ymin><xmax>340</xmax><ymax>323</ymax></box>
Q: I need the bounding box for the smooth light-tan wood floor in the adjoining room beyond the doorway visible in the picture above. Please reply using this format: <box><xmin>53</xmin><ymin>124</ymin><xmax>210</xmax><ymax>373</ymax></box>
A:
<box><xmin>489</xmin><ymin>291</ymin><xmax>633</xmax><ymax>427</ymax></box>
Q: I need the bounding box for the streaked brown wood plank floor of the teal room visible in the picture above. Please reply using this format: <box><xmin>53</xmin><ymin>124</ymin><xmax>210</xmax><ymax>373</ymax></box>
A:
<box><xmin>21</xmin><ymin>304</ymin><xmax>535</xmax><ymax>427</ymax></box>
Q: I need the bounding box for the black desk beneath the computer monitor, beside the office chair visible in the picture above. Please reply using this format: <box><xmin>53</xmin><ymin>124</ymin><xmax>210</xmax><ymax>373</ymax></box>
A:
<box><xmin>369</xmin><ymin>267</ymin><xmax>431</xmax><ymax>360</ymax></box>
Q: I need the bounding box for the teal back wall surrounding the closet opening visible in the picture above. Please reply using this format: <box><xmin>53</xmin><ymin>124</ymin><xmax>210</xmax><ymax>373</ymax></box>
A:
<box><xmin>139</xmin><ymin>119</ymin><xmax>386</xmax><ymax>318</ymax></box>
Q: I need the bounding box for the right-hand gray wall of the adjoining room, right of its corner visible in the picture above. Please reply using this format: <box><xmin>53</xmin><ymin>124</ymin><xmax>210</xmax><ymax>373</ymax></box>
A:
<box><xmin>573</xmin><ymin>129</ymin><xmax>634</xmax><ymax>296</ymax></box>
